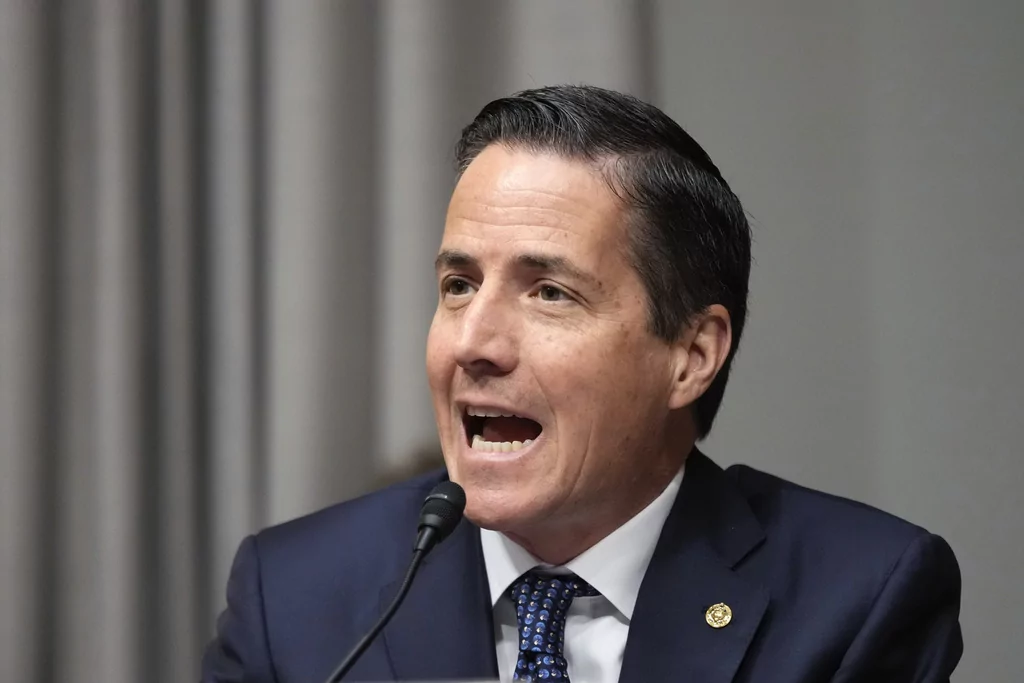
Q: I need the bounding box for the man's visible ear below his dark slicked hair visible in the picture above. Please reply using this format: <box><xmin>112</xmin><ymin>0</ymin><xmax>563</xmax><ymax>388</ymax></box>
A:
<box><xmin>669</xmin><ymin>304</ymin><xmax>732</xmax><ymax>410</ymax></box>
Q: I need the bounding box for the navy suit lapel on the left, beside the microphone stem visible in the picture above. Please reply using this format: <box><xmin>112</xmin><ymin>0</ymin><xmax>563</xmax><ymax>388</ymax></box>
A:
<box><xmin>381</xmin><ymin>520</ymin><xmax>498</xmax><ymax>680</ymax></box>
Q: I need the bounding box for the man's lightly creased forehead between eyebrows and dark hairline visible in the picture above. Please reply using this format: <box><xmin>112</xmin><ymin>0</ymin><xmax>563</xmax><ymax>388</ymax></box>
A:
<box><xmin>443</xmin><ymin>145</ymin><xmax>625</xmax><ymax>255</ymax></box>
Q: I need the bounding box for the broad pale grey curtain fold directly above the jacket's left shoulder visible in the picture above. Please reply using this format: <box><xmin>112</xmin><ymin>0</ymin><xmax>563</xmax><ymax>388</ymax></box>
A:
<box><xmin>265</xmin><ymin>3</ymin><xmax>384</xmax><ymax>519</ymax></box>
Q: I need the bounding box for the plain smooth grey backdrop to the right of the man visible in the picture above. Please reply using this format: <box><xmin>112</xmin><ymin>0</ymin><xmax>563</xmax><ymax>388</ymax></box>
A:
<box><xmin>655</xmin><ymin>0</ymin><xmax>1024</xmax><ymax>682</ymax></box>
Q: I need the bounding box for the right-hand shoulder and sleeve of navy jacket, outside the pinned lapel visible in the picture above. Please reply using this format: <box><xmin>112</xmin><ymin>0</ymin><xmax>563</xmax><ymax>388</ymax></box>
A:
<box><xmin>726</xmin><ymin>458</ymin><xmax>962</xmax><ymax>681</ymax></box>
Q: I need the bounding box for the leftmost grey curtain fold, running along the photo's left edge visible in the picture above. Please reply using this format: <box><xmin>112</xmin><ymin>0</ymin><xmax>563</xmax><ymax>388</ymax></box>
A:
<box><xmin>0</xmin><ymin>3</ymin><xmax>52</xmax><ymax>680</ymax></box>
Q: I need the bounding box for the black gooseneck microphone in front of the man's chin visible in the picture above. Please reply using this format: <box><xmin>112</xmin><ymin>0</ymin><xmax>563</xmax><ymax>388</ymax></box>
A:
<box><xmin>326</xmin><ymin>481</ymin><xmax>466</xmax><ymax>683</ymax></box>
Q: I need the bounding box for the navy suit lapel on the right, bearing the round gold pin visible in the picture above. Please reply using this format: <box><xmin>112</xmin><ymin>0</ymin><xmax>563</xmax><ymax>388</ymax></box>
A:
<box><xmin>620</xmin><ymin>449</ymin><xmax>768</xmax><ymax>683</ymax></box>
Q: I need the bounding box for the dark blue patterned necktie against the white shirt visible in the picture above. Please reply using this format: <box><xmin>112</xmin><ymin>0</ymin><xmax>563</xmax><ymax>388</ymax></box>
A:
<box><xmin>510</xmin><ymin>571</ymin><xmax>599</xmax><ymax>681</ymax></box>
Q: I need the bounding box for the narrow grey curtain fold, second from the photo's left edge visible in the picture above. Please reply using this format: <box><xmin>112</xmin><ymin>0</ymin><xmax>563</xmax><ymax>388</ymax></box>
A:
<box><xmin>52</xmin><ymin>3</ymin><xmax>99</xmax><ymax>683</ymax></box>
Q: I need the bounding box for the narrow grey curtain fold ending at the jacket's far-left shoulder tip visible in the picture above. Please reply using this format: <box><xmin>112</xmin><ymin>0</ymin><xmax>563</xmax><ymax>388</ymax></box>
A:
<box><xmin>205</xmin><ymin>2</ymin><xmax>267</xmax><ymax>634</ymax></box>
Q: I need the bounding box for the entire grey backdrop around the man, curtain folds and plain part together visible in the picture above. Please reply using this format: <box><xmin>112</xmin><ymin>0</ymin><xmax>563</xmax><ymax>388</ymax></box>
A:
<box><xmin>0</xmin><ymin>0</ymin><xmax>1024</xmax><ymax>683</ymax></box>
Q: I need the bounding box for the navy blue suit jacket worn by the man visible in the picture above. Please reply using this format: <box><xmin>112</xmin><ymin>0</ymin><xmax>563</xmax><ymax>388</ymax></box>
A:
<box><xmin>202</xmin><ymin>451</ymin><xmax>963</xmax><ymax>683</ymax></box>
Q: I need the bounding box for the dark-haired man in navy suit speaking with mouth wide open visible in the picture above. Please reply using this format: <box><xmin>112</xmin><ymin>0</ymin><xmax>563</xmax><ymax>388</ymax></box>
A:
<box><xmin>203</xmin><ymin>87</ymin><xmax>962</xmax><ymax>683</ymax></box>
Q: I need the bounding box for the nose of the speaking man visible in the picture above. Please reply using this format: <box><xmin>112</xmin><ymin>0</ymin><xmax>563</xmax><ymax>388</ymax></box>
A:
<box><xmin>455</xmin><ymin>289</ymin><xmax>519</xmax><ymax>378</ymax></box>
